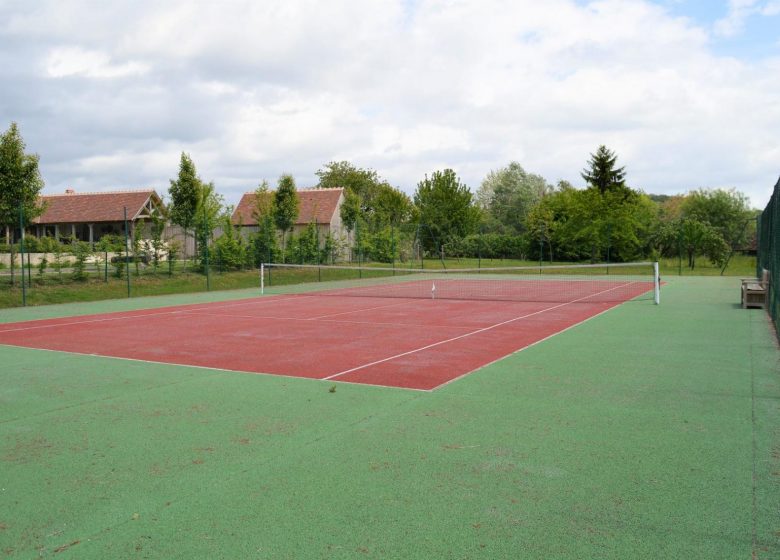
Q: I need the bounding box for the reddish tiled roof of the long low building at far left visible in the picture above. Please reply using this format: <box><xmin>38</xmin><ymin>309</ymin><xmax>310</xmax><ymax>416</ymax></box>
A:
<box><xmin>33</xmin><ymin>189</ymin><xmax>159</xmax><ymax>224</ymax></box>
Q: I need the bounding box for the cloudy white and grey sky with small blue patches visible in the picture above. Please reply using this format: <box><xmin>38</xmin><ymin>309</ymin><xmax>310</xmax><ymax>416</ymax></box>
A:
<box><xmin>0</xmin><ymin>0</ymin><xmax>780</xmax><ymax>208</ymax></box>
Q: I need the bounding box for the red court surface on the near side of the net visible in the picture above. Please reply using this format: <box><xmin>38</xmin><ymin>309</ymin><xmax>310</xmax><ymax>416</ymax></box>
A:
<box><xmin>0</xmin><ymin>282</ymin><xmax>652</xmax><ymax>390</ymax></box>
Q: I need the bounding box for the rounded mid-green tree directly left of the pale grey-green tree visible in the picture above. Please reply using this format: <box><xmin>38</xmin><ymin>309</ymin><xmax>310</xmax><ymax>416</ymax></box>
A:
<box><xmin>414</xmin><ymin>169</ymin><xmax>480</xmax><ymax>250</ymax></box>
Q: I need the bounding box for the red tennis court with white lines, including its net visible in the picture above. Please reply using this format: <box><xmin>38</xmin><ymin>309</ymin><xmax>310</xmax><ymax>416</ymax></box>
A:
<box><xmin>0</xmin><ymin>263</ymin><xmax>655</xmax><ymax>390</ymax></box>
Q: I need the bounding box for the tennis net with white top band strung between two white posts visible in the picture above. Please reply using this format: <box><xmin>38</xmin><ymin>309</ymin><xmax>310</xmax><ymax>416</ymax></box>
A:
<box><xmin>260</xmin><ymin>262</ymin><xmax>660</xmax><ymax>303</ymax></box>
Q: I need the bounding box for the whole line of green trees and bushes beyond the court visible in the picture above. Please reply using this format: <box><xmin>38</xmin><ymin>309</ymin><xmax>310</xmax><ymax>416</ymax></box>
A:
<box><xmin>0</xmin><ymin>123</ymin><xmax>756</xmax><ymax>274</ymax></box>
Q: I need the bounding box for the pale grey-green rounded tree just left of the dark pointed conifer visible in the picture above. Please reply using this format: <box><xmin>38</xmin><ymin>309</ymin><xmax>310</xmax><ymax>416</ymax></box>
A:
<box><xmin>476</xmin><ymin>161</ymin><xmax>552</xmax><ymax>233</ymax></box>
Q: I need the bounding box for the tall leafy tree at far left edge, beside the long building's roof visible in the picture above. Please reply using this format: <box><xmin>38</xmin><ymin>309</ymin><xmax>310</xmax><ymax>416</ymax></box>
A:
<box><xmin>0</xmin><ymin>122</ymin><xmax>44</xmax><ymax>243</ymax></box>
